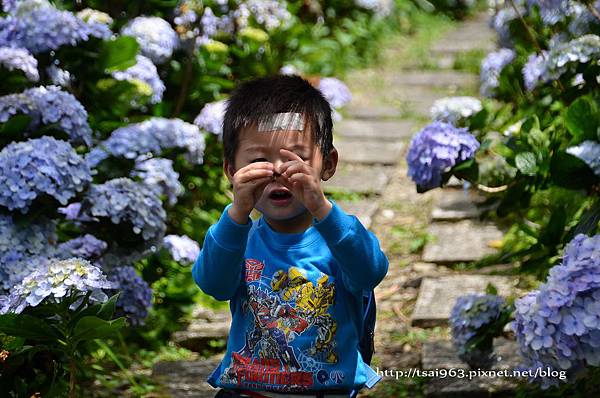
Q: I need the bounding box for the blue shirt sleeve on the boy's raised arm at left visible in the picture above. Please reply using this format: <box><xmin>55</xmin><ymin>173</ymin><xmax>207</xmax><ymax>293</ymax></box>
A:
<box><xmin>192</xmin><ymin>203</ymin><xmax>252</xmax><ymax>301</ymax></box>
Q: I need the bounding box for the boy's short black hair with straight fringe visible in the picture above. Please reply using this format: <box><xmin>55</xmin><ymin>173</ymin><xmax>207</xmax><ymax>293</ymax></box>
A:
<box><xmin>223</xmin><ymin>75</ymin><xmax>333</xmax><ymax>165</ymax></box>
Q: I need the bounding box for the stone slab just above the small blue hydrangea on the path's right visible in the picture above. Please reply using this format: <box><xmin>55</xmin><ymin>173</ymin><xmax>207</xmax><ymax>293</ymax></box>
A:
<box><xmin>411</xmin><ymin>274</ymin><xmax>517</xmax><ymax>327</ymax></box>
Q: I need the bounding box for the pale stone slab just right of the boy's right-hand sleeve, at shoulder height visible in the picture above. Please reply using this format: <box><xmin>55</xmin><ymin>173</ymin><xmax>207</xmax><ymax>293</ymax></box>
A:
<box><xmin>422</xmin><ymin>220</ymin><xmax>504</xmax><ymax>264</ymax></box>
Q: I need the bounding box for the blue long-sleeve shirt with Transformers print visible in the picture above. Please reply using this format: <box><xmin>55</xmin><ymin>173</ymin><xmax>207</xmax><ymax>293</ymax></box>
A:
<box><xmin>192</xmin><ymin>199</ymin><xmax>388</xmax><ymax>392</ymax></box>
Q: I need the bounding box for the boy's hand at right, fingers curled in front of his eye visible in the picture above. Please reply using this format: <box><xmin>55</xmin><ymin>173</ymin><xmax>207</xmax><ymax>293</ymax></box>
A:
<box><xmin>278</xmin><ymin>148</ymin><xmax>333</xmax><ymax>220</ymax></box>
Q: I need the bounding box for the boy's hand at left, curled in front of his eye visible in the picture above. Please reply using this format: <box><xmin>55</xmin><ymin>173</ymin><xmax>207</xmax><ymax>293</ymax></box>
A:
<box><xmin>228</xmin><ymin>162</ymin><xmax>273</xmax><ymax>224</ymax></box>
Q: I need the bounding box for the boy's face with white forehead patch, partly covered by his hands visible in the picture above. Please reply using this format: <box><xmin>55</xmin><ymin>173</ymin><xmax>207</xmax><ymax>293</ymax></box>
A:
<box><xmin>225</xmin><ymin>118</ymin><xmax>337</xmax><ymax>221</ymax></box>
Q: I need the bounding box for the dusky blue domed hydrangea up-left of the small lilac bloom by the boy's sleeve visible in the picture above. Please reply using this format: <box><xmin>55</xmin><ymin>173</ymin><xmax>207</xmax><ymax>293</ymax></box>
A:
<box><xmin>82</xmin><ymin>178</ymin><xmax>166</xmax><ymax>240</ymax></box>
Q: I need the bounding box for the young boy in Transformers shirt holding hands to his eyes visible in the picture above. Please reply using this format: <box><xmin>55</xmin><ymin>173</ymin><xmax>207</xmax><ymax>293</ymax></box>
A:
<box><xmin>192</xmin><ymin>75</ymin><xmax>388</xmax><ymax>397</ymax></box>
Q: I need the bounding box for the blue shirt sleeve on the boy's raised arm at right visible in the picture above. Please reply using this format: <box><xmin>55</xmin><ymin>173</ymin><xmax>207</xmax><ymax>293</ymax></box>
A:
<box><xmin>313</xmin><ymin>199</ymin><xmax>389</xmax><ymax>291</ymax></box>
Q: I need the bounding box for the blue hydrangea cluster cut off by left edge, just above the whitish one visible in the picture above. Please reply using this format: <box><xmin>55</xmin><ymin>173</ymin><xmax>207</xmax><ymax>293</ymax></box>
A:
<box><xmin>0</xmin><ymin>214</ymin><xmax>58</xmax><ymax>291</ymax></box>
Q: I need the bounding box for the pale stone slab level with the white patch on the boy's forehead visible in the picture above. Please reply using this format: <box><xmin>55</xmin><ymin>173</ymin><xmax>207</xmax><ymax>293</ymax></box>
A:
<box><xmin>334</xmin><ymin>119</ymin><xmax>415</xmax><ymax>141</ymax></box>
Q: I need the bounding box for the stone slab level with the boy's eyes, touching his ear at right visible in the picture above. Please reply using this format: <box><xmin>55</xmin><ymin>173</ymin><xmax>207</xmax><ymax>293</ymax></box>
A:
<box><xmin>335</xmin><ymin>140</ymin><xmax>404</xmax><ymax>165</ymax></box>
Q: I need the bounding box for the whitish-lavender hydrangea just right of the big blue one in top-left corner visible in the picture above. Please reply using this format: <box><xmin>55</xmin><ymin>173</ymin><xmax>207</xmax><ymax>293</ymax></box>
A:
<box><xmin>121</xmin><ymin>16</ymin><xmax>179</xmax><ymax>64</ymax></box>
